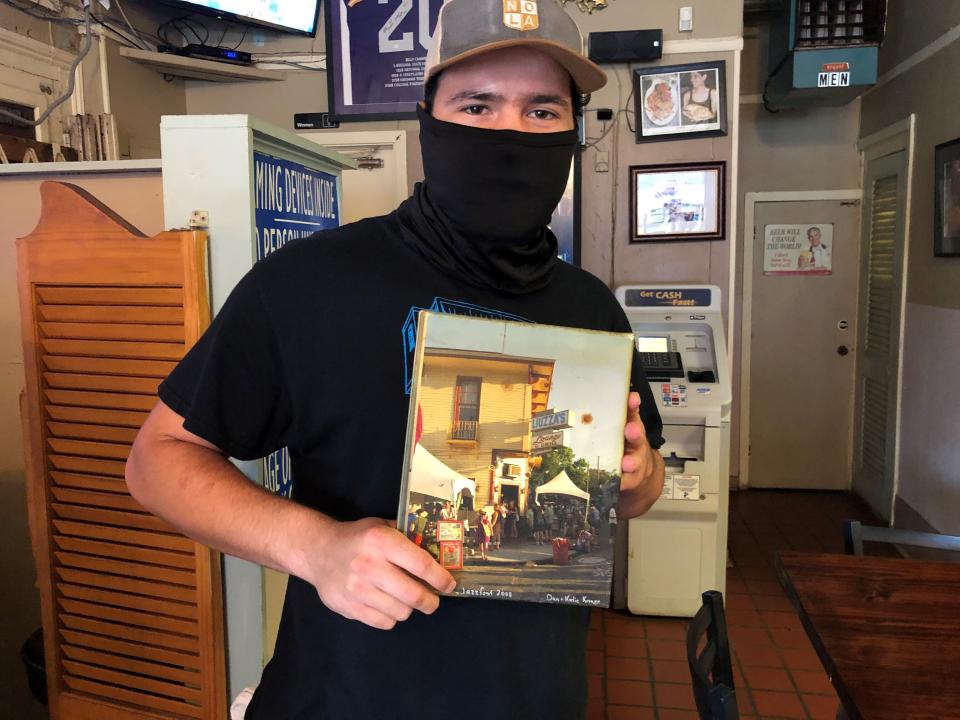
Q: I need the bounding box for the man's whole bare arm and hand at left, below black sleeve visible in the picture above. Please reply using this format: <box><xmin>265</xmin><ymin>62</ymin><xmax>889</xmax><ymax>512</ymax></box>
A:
<box><xmin>126</xmin><ymin>402</ymin><xmax>456</xmax><ymax>629</ymax></box>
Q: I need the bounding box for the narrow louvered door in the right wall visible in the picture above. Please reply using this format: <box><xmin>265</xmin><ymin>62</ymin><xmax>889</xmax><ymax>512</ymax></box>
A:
<box><xmin>853</xmin><ymin>151</ymin><xmax>906</xmax><ymax>522</ymax></box>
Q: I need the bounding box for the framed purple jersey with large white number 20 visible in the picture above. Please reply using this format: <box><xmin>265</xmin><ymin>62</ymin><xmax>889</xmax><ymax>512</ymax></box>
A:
<box><xmin>324</xmin><ymin>0</ymin><xmax>443</xmax><ymax>120</ymax></box>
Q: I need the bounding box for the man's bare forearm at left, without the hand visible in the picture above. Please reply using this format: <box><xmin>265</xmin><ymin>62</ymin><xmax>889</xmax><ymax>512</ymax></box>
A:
<box><xmin>126</xmin><ymin>433</ymin><xmax>334</xmax><ymax>577</ymax></box>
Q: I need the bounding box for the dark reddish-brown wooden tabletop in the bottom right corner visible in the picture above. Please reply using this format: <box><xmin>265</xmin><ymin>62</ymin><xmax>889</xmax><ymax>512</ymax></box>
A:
<box><xmin>777</xmin><ymin>552</ymin><xmax>960</xmax><ymax>720</ymax></box>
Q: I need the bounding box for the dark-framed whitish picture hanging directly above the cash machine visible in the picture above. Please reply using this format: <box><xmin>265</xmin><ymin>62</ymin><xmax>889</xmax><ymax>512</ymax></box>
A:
<box><xmin>630</xmin><ymin>162</ymin><xmax>726</xmax><ymax>243</ymax></box>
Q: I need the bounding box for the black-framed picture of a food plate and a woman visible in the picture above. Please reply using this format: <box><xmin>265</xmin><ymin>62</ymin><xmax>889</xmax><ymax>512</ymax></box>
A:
<box><xmin>633</xmin><ymin>60</ymin><xmax>727</xmax><ymax>143</ymax></box>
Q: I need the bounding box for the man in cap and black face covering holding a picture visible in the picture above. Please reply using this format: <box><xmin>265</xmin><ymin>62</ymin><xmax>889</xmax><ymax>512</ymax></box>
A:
<box><xmin>127</xmin><ymin>0</ymin><xmax>663</xmax><ymax>720</ymax></box>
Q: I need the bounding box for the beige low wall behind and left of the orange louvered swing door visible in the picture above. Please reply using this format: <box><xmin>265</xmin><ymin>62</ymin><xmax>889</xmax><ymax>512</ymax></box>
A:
<box><xmin>0</xmin><ymin>173</ymin><xmax>163</xmax><ymax>720</ymax></box>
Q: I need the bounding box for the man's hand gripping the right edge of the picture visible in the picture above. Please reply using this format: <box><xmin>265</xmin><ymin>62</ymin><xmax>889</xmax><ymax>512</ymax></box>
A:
<box><xmin>617</xmin><ymin>392</ymin><xmax>664</xmax><ymax>519</ymax></box>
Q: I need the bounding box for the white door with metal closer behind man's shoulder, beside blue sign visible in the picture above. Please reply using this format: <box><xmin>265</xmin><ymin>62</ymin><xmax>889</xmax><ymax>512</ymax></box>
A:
<box><xmin>299</xmin><ymin>130</ymin><xmax>409</xmax><ymax>225</ymax></box>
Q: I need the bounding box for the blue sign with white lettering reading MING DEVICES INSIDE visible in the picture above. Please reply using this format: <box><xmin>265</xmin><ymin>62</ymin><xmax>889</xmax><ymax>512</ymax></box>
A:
<box><xmin>253</xmin><ymin>152</ymin><xmax>340</xmax><ymax>497</ymax></box>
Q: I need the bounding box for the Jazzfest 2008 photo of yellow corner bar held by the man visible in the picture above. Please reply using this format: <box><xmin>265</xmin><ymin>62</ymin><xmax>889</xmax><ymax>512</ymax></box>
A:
<box><xmin>398</xmin><ymin>311</ymin><xmax>633</xmax><ymax>607</ymax></box>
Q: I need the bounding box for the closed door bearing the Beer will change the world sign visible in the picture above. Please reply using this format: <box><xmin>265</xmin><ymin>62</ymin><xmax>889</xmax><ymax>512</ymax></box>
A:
<box><xmin>744</xmin><ymin>200</ymin><xmax>860</xmax><ymax>490</ymax></box>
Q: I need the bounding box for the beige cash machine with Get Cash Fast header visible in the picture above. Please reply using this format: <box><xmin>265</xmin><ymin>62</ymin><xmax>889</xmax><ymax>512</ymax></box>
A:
<box><xmin>616</xmin><ymin>285</ymin><xmax>732</xmax><ymax>617</ymax></box>
